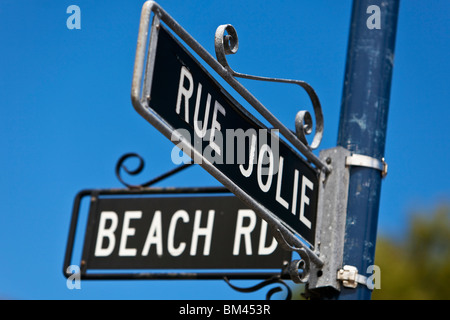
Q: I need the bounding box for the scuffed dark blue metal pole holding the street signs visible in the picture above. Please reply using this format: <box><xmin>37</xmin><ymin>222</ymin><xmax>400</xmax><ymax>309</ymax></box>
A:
<box><xmin>337</xmin><ymin>0</ymin><xmax>400</xmax><ymax>300</ymax></box>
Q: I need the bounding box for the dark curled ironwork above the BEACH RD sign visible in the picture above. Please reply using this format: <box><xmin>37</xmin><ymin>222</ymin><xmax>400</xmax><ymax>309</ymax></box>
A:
<box><xmin>115</xmin><ymin>153</ymin><xmax>193</xmax><ymax>189</ymax></box>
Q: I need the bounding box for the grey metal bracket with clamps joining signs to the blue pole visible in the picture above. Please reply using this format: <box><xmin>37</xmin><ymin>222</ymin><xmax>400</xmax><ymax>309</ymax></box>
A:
<box><xmin>307</xmin><ymin>147</ymin><xmax>387</xmax><ymax>292</ymax></box>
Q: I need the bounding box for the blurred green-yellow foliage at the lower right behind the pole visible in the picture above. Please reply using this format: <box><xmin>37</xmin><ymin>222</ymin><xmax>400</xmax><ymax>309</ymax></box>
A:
<box><xmin>372</xmin><ymin>206</ymin><xmax>450</xmax><ymax>300</ymax></box>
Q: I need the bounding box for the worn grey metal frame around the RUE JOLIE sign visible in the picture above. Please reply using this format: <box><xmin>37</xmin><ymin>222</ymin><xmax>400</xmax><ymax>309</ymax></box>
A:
<box><xmin>131</xmin><ymin>1</ymin><xmax>331</xmax><ymax>268</ymax></box>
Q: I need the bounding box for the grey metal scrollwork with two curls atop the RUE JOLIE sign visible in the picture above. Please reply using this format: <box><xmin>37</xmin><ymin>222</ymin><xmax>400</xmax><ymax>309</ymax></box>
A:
<box><xmin>214</xmin><ymin>24</ymin><xmax>324</xmax><ymax>150</ymax></box>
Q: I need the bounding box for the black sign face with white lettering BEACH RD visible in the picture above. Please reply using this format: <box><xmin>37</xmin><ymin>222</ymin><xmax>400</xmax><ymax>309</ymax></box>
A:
<box><xmin>83</xmin><ymin>191</ymin><xmax>290</xmax><ymax>270</ymax></box>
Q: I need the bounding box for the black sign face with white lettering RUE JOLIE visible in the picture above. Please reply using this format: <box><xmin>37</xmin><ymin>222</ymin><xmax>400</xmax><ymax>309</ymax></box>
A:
<box><xmin>144</xmin><ymin>25</ymin><xmax>319</xmax><ymax>244</ymax></box>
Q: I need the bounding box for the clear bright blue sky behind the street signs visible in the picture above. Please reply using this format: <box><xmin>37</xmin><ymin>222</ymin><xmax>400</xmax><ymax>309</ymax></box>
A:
<box><xmin>0</xmin><ymin>0</ymin><xmax>450</xmax><ymax>299</ymax></box>
